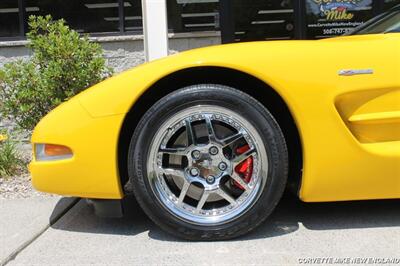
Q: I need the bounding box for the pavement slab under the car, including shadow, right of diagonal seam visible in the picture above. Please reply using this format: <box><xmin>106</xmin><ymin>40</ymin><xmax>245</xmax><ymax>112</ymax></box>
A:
<box><xmin>3</xmin><ymin>193</ymin><xmax>400</xmax><ymax>265</ymax></box>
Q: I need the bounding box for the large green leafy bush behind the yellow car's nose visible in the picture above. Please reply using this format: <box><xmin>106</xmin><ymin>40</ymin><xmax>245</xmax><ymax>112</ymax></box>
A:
<box><xmin>0</xmin><ymin>16</ymin><xmax>112</xmax><ymax>130</ymax></box>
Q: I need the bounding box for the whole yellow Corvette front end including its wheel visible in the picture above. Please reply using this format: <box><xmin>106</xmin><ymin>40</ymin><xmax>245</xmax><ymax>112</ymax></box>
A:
<box><xmin>30</xmin><ymin>7</ymin><xmax>400</xmax><ymax>240</ymax></box>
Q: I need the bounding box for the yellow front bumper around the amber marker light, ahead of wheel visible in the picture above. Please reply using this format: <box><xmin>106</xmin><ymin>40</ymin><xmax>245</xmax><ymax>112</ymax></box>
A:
<box><xmin>29</xmin><ymin>98</ymin><xmax>125</xmax><ymax>199</ymax></box>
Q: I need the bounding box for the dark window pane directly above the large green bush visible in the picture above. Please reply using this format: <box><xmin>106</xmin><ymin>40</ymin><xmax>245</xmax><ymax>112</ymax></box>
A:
<box><xmin>26</xmin><ymin>0</ymin><xmax>120</xmax><ymax>33</ymax></box>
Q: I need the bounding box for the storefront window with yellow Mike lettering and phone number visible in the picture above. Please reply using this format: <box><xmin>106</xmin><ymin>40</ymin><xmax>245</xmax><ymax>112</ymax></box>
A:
<box><xmin>306</xmin><ymin>0</ymin><xmax>373</xmax><ymax>39</ymax></box>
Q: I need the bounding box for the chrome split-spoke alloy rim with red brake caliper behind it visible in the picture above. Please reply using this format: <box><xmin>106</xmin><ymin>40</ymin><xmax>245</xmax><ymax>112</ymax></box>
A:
<box><xmin>147</xmin><ymin>105</ymin><xmax>268</xmax><ymax>225</ymax></box>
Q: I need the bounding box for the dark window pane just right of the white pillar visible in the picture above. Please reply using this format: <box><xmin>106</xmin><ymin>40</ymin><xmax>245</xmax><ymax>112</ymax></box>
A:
<box><xmin>167</xmin><ymin>0</ymin><xmax>219</xmax><ymax>32</ymax></box>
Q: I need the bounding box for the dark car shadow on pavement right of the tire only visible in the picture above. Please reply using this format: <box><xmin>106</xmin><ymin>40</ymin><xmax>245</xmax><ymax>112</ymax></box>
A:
<box><xmin>242</xmin><ymin>194</ymin><xmax>400</xmax><ymax>239</ymax></box>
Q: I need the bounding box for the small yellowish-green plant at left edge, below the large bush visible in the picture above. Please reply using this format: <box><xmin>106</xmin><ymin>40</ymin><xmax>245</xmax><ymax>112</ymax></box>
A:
<box><xmin>0</xmin><ymin>134</ymin><xmax>24</xmax><ymax>178</ymax></box>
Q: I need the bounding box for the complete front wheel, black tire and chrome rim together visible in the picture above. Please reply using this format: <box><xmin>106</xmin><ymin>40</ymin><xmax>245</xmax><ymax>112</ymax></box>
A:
<box><xmin>128</xmin><ymin>84</ymin><xmax>288</xmax><ymax>240</ymax></box>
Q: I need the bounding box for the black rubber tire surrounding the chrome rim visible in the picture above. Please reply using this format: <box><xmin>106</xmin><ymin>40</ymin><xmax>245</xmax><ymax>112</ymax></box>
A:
<box><xmin>128</xmin><ymin>84</ymin><xmax>289</xmax><ymax>240</ymax></box>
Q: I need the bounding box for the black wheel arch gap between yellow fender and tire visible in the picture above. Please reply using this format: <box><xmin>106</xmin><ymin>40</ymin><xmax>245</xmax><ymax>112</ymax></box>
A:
<box><xmin>117</xmin><ymin>67</ymin><xmax>303</xmax><ymax>193</ymax></box>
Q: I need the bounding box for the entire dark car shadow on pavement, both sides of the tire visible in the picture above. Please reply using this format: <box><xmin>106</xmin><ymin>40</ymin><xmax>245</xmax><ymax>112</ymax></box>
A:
<box><xmin>52</xmin><ymin>193</ymin><xmax>400</xmax><ymax>242</ymax></box>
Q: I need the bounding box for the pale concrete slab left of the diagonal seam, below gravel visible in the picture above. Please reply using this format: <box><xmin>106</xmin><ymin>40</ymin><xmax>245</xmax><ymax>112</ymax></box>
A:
<box><xmin>0</xmin><ymin>197</ymin><xmax>76</xmax><ymax>265</ymax></box>
